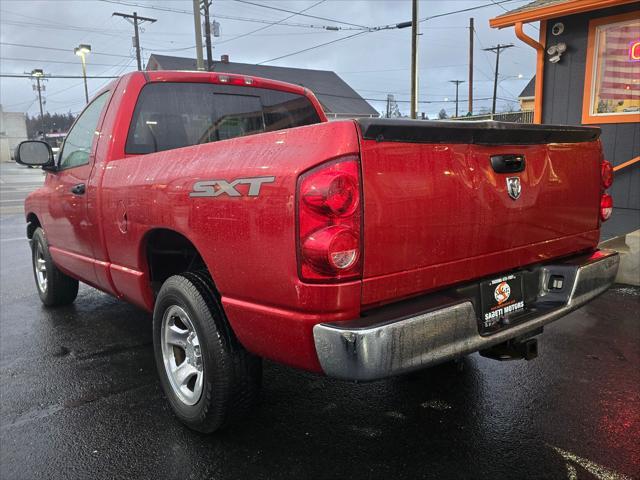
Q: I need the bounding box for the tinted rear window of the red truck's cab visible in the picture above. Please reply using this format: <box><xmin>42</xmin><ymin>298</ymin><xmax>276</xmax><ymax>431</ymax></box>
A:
<box><xmin>125</xmin><ymin>83</ymin><xmax>320</xmax><ymax>153</ymax></box>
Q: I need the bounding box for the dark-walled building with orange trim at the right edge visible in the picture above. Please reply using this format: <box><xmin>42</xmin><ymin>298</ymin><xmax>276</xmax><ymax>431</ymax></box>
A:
<box><xmin>490</xmin><ymin>0</ymin><xmax>640</xmax><ymax>237</ymax></box>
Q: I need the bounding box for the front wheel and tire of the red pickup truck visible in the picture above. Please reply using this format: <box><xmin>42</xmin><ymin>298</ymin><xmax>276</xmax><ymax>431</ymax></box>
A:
<box><xmin>31</xmin><ymin>227</ymin><xmax>78</xmax><ymax>307</ymax></box>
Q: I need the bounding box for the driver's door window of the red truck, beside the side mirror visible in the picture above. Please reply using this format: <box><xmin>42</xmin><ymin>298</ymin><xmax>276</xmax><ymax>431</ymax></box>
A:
<box><xmin>58</xmin><ymin>92</ymin><xmax>109</xmax><ymax>169</ymax></box>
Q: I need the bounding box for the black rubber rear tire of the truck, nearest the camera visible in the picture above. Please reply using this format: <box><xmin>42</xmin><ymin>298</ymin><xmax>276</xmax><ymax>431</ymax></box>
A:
<box><xmin>153</xmin><ymin>272</ymin><xmax>262</xmax><ymax>433</ymax></box>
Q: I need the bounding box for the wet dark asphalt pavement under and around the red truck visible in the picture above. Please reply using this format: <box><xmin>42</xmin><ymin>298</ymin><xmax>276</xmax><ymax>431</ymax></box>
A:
<box><xmin>0</xmin><ymin>215</ymin><xmax>640</xmax><ymax>480</ymax></box>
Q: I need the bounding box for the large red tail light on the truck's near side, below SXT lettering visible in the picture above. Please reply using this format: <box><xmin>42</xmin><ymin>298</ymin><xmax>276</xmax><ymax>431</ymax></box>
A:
<box><xmin>297</xmin><ymin>155</ymin><xmax>362</xmax><ymax>282</ymax></box>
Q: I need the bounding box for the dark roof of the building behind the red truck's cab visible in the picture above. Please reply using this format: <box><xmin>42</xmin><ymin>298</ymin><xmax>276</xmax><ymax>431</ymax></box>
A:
<box><xmin>147</xmin><ymin>54</ymin><xmax>378</xmax><ymax>119</ymax></box>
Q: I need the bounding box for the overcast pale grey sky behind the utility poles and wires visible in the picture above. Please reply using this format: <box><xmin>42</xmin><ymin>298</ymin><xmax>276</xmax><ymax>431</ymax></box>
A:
<box><xmin>0</xmin><ymin>0</ymin><xmax>538</xmax><ymax>117</ymax></box>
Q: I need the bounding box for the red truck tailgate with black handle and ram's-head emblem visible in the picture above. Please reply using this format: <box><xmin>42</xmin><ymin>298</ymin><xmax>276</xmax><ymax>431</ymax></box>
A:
<box><xmin>358</xmin><ymin>119</ymin><xmax>601</xmax><ymax>305</ymax></box>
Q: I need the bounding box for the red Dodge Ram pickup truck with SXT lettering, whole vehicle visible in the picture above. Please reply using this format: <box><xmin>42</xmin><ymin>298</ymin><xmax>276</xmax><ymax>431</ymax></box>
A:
<box><xmin>16</xmin><ymin>71</ymin><xmax>618</xmax><ymax>432</ymax></box>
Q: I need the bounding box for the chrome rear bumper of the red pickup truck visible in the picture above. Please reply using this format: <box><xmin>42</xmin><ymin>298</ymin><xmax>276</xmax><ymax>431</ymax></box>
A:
<box><xmin>313</xmin><ymin>251</ymin><xmax>619</xmax><ymax>380</ymax></box>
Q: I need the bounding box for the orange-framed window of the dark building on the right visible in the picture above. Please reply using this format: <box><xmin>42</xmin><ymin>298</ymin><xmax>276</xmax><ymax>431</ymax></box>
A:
<box><xmin>582</xmin><ymin>13</ymin><xmax>640</xmax><ymax>124</ymax></box>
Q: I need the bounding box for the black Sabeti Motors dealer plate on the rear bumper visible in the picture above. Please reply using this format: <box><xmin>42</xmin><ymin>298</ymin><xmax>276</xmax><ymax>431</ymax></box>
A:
<box><xmin>480</xmin><ymin>272</ymin><xmax>526</xmax><ymax>333</ymax></box>
